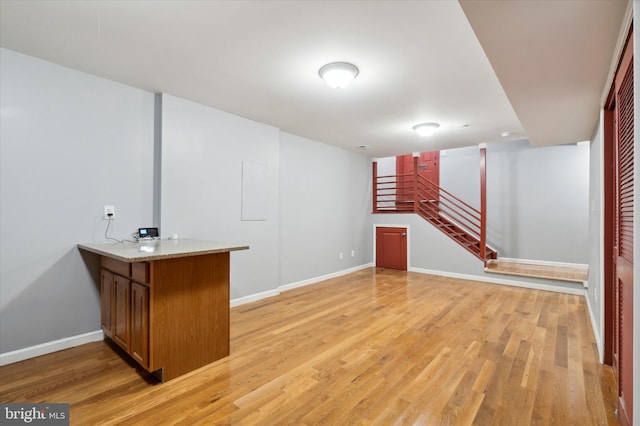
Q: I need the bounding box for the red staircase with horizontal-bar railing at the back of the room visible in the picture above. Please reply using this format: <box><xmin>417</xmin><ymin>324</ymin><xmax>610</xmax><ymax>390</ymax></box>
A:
<box><xmin>373</xmin><ymin>163</ymin><xmax>498</xmax><ymax>265</ymax></box>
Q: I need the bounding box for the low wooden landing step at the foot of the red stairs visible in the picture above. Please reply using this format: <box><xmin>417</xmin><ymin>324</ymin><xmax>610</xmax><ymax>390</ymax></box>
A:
<box><xmin>484</xmin><ymin>259</ymin><xmax>589</xmax><ymax>283</ymax></box>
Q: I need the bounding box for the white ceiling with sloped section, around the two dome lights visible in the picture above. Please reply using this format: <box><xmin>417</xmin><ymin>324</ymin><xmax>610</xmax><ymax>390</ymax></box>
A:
<box><xmin>0</xmin><ymin>0</ymin><xmax>629</xmax><ymax>157</ymax></box>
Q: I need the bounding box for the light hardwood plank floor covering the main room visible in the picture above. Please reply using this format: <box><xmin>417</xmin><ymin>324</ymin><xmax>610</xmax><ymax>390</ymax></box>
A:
<box><xmin>0</xmin><ymin>268</ymin><xmax>618</xmax><ymax>425</ymax></box>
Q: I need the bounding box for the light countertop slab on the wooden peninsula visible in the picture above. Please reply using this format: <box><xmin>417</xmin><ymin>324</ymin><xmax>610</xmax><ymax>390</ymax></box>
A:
<box><xmin>78</xmin><ymin>238</ymin><xmax>249</xmax><ymax>263</ymax></box>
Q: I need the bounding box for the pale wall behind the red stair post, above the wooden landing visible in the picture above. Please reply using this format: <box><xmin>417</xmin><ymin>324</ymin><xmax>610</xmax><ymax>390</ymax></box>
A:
<box><xmin>440</xmin><ymin>140</ymin><xmax>589</xmax><ymax>264</ymax></box>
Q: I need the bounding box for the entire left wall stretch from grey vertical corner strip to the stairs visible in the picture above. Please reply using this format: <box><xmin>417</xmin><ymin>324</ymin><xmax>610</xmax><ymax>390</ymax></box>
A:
<box><xmin>160</xmin><ymin>95</ymin><xmax>371</xmax><ymax>299</ymax></box>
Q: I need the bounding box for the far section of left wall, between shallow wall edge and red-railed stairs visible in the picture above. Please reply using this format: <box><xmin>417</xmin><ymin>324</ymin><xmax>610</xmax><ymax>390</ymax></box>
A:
<box><xmin>280</xmin><ymin>132</ymin><xmax>372</xmax><ymax>285</ymax></box>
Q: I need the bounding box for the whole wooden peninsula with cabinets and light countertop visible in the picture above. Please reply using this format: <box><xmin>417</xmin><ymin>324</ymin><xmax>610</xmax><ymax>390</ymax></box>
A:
<box><xmin>78</xmin><ymin>239</ymin><xmax>249</xmax><ymax>381</ymax></box>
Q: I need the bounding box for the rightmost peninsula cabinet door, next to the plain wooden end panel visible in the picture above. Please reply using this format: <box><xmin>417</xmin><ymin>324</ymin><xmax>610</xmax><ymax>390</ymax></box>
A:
<box><xmin>129</xmin><ymin>282</ymin><xmax>149</xmax><ymax>368</ymax></box>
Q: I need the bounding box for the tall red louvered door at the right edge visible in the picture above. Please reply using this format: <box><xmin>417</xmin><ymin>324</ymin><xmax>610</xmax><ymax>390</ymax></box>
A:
<box><xmin>613</xmin><ymin>29</ymin><xmax>634</xmax><ymax>426</ymax></box>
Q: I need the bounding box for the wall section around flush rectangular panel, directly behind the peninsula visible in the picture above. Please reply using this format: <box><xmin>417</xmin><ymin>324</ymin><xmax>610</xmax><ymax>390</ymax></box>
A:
<box><xmin>160</xmin><ymin>95</ymin><xmax>280</xmax><ymax>299</ymax></box>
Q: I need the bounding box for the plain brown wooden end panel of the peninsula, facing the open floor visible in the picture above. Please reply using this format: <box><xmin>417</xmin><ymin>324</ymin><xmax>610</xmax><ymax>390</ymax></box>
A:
<box><xmin>149</xmin><ymin>252</ymin><xmax>229</xmax><ymax>380</ymax></box>
